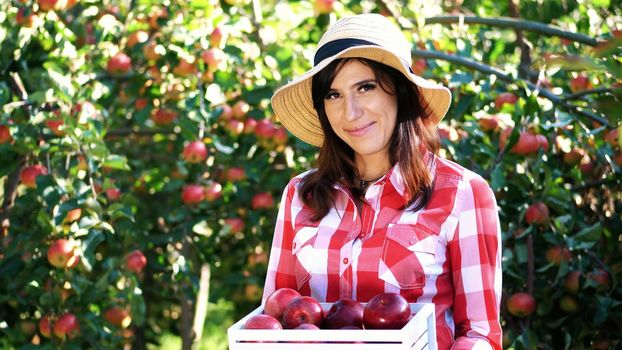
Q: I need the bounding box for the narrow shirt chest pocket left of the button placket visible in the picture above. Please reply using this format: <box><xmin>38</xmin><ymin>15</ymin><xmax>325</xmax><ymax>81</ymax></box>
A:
<box><xmin>292</xmin><ymin>227</ymin><xmax>318</xmax><ymax>290</ymax></box>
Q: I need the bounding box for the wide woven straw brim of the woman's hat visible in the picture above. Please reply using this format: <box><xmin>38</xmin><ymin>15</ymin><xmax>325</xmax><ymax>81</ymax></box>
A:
<box><xmin>272</xmin><ymin>45</ymin><xmax>451</xmax><ymax>147</ymax></box>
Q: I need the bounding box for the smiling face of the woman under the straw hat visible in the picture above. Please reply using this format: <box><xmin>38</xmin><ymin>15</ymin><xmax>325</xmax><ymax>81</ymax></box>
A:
<box><xmin>324</xmin><ymin>60</ymin><xmax>397</xmax><ymax>164</ymax></box>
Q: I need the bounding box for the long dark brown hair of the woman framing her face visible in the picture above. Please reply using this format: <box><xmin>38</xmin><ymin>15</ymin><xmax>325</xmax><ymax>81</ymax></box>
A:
<box><xmin>300</xmin><ymin>58</ymin><xmax>439</xmax><ymax>221</ymax></box>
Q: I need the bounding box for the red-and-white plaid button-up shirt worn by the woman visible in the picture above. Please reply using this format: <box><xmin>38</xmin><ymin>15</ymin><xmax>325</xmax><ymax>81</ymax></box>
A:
<box><xmin>263</xmin><ymin>152</ymin><xmax>502</xmax><ymax>349</ymax></box>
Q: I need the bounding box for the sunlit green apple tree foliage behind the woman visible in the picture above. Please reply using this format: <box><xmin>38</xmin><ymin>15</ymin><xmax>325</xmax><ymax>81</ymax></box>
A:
<box><xmin>0</xmin><ymin>0</ymin><xmax>622</xmax><ymax>349</ymax></box>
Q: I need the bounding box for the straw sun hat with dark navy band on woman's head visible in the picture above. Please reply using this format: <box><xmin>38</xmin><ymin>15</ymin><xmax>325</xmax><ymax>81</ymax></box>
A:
<box><xmin>272</xmin><ymin>14</ymin><xmax>451</xmax><ymax>146</ymax></box>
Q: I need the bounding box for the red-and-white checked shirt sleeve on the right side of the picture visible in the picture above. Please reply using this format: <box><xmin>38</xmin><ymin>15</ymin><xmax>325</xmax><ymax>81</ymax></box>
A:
<box><xmin>448</xmin><ymin>176</ymin><xmax>502</xmax><ymax>350</ymax></box>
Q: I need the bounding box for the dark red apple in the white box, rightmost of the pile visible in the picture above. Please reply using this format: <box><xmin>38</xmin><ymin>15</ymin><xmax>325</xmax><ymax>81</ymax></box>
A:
<box><xmin>363</xmin><ymin>293</ymin><xmax>411</xmax><ymax>329</ymax></box>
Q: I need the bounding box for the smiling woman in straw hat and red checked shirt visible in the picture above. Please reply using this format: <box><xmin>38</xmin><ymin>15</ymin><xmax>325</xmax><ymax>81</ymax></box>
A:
<box><xmin>264</xmin><ymin>14</ymin><xmax>501</xmax><ymax>349</ymax></box>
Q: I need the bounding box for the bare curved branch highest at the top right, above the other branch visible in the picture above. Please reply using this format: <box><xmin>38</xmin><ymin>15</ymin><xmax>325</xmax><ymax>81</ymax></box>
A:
<box><xmin>425</xmin><ymin>16</ymin><xmax>598</xmax><ymax>46</ymax></box>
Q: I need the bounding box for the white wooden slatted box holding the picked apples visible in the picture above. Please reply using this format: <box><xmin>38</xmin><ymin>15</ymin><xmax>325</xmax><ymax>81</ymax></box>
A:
<box><xmin>227</xmin><ymin>303</ymin><xmax>437</xmax><ymax>350</ymax></box>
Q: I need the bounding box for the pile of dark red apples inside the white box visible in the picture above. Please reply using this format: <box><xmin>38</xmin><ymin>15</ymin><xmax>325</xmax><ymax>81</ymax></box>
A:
<box><xmin>244</xmin><ymin>288</ymin><xmax>412</xmax><ymax>330</ymax></box>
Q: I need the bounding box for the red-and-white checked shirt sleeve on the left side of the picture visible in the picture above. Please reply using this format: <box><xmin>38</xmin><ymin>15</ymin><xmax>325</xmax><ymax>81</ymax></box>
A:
<box><xmin>261</xmin><ymin>180</ymin><xmax>298</xmax><ymax>305</ymax></box>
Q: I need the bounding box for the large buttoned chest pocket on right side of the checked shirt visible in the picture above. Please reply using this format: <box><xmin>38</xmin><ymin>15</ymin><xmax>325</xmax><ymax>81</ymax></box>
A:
<box><xmin>378</xmin><ymin>224</ymin><xmax>438</xmax><ymax>289</ymax></box>
